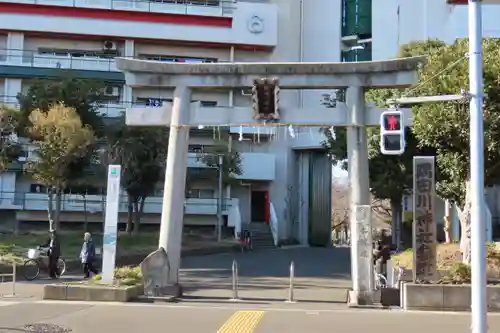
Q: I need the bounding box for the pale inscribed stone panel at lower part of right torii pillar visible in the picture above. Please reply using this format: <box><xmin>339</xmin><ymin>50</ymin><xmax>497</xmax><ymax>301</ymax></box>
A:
<box><xmin>352</xmin><ymin>205</ymin><xmax>373</xmax><ymax>294</ymax></box>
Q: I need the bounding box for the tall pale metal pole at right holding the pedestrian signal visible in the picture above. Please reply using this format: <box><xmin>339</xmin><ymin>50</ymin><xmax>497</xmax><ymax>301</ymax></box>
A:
<box><xmin>469</xmin><ymin>0</ymin><xmax>487</xmax><ymax>333</ymax></box>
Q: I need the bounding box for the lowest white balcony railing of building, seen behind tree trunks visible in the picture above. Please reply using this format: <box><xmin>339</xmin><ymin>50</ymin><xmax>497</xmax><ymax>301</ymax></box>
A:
<box><xmin>7</xmin><ymin>193</ymin><xmax>238</xmax><ymax>215</ymax></box>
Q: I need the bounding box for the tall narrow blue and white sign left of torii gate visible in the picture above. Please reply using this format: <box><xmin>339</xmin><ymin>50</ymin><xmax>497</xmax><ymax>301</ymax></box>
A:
<box><xmin>101</xmin><ymin>165</ymin><xmax>121</xmax><ymax>284</ymax></box>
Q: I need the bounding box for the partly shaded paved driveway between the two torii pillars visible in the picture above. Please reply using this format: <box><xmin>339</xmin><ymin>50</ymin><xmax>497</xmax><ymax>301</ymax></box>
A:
<box><xmin>180</xmin><ymin>248</ymin><xmax>351</xmax><ymax>303</ymax></box>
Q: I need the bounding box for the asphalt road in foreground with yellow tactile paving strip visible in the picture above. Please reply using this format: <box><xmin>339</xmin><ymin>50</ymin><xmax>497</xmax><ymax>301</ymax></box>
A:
<box><xmin>0</xmin><ymin>301</ymin><xmax>500</xmax><ymax>333</ymax></box>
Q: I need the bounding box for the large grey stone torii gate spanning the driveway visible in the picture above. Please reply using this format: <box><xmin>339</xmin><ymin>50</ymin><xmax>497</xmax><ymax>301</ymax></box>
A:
<box><xmin>116</xmin><ymin>57</ymin><xmax>425</xmax><ymax>304</ymax></box>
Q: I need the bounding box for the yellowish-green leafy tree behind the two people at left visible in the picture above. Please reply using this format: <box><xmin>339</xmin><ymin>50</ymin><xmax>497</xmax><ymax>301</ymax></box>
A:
<box><xmin>28</xmin><ymin>104</ymin><xmax>94</xmax><ymax>229</ymax></box>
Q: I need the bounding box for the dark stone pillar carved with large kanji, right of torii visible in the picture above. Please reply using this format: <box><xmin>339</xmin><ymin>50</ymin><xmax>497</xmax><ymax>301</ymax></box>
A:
<box><xmin>413</xmin><ymin>156</ymin><xmax>436</xmax><ymax>282</ymax></box>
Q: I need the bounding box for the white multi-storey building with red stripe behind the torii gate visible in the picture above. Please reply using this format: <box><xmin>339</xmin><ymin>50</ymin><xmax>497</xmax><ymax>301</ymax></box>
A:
<box><xmin>0</xmin><ymin>0</ymin><xmax>343</xmax><ymax>244</ymax></box>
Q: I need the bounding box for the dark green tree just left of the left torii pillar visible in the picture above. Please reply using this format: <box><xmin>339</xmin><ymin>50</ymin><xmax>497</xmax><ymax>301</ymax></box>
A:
<box><xmin>105</xmin><ymin>119</ymin><xmax>168</xmax><ymax>234</ymax></box>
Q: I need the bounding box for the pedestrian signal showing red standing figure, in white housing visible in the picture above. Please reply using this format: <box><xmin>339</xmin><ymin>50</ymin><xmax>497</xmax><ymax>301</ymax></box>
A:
<box><xmin>380</xmin><ymin>110</ymin><xmax>405</xmax><ymax>155</ymax></box>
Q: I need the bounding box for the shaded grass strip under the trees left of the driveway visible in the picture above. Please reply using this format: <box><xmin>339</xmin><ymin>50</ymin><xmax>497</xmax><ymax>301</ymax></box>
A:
<box><xmin>0</xmin><ymin>231</ymin><xmax>234</xmax><ymax>263</ymax></box>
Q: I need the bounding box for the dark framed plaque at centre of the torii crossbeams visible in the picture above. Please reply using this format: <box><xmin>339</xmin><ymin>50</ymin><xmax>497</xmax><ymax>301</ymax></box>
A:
<box><xmin>252</xmin><ymin>78</ymin><xmax>280</xmax><ymax>120</ymax></box>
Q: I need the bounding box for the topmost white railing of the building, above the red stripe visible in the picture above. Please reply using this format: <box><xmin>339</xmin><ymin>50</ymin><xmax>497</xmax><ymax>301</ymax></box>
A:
<box><xmin>0</xmin><ymin>0</ymin><xmax>237</xmax><ymax>16</ymax></box>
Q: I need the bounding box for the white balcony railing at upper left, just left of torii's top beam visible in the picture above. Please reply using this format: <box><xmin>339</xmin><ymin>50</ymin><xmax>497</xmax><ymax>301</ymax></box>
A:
<box><xmin>0</xmin><ymin>50</ymin><xmax>118</xmax><ymax>72</ymax></box>
